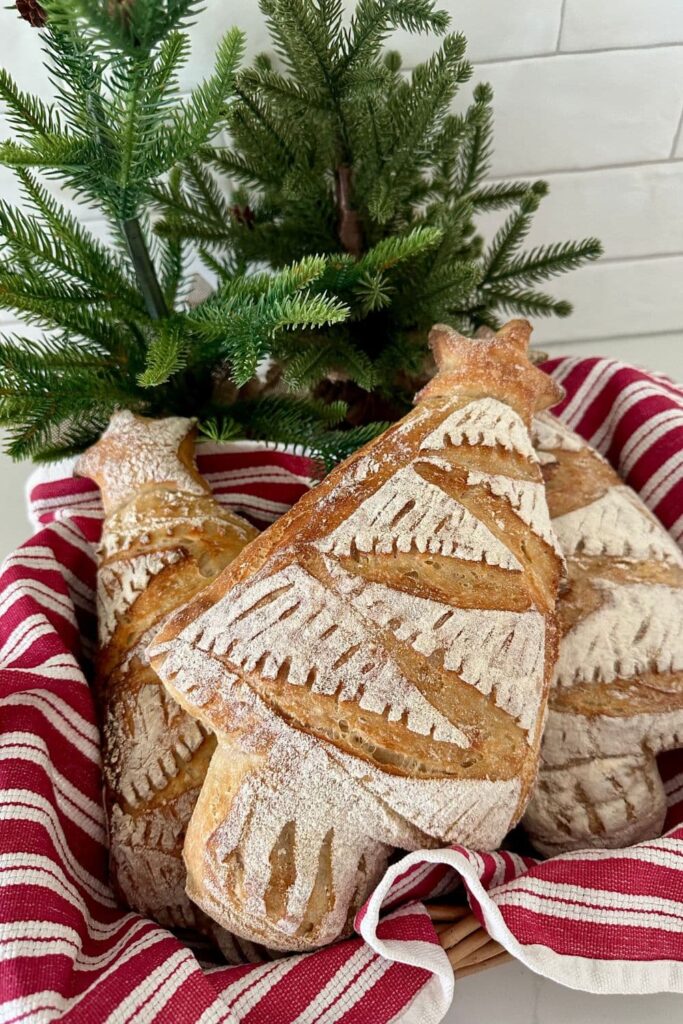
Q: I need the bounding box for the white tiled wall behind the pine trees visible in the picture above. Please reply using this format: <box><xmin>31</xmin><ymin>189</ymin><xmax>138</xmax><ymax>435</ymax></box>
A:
<box><xmin>0</xmin><ymin>0</ymin><xmax>683</xmax><ymax>550</ymax></box>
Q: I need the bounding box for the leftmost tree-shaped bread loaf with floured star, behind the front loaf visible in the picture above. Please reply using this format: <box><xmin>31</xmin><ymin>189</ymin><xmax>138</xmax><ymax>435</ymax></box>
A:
<box><xmin>77</xmin><ymin>413</ymin><xmax>257</xmax><ymax>954</ymax></box>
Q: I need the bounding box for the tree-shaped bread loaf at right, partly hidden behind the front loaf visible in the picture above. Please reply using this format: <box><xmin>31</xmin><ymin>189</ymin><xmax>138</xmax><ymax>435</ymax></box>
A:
<box><xmin>524</xmin><ymin>414</ymin><xmax>683</xmax><ymax>854</ymax></box>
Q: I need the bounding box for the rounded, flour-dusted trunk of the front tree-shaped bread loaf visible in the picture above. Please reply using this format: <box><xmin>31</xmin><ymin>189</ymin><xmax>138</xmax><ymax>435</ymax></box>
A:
<box><xmin>184</xmin><ymin>734</ymin><xmax>397</xmax><ymax>952</ymax></box>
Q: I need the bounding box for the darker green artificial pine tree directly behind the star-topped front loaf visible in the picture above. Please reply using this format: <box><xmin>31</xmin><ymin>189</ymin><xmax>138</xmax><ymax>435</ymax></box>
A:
<box><xmin>157</xmin><ymin>0</ymin><xmax>600</xmax><ymax>422</ymax></box>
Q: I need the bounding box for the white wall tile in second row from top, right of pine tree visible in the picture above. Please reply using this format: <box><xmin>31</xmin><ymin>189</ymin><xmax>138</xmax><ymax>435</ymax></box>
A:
<box><xmin>475</xmin><ymin>46</ymin><xmax>683</xmax><ymax>175</ymax></box>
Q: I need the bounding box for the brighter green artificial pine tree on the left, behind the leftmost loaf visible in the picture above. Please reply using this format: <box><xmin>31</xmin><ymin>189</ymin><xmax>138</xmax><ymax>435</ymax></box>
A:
<box><xmin>0</xmin><ymin>0</ymin><xmax>372</xmax><ymax>462</ymax></box>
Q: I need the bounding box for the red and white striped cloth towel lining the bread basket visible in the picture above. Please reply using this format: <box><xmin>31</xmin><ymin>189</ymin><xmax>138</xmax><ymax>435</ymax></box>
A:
<box><xmin>0</xmin><ymin>359</ymin><xmax>683</xmax><ymax>1024</ymax></box>
